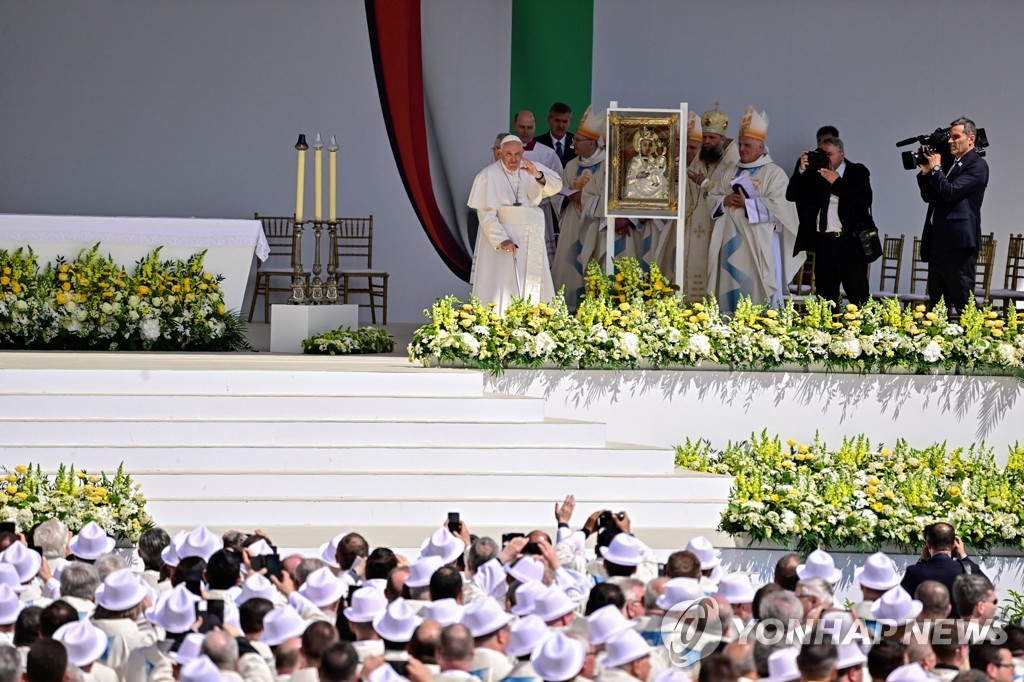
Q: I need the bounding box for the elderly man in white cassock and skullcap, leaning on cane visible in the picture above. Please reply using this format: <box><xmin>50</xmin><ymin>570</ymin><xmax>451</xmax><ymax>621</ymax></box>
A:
<box><xmin>467</xmin><ymin>135</ymin><xmax>562</xmax><ymax>313</ymax></box>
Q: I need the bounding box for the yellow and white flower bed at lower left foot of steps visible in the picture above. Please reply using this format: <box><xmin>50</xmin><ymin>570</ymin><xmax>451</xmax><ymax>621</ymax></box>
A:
<box><xmin>0</xmin><ymin>464</ymin><xmax>153</xmax><ymax>542</ymax></box>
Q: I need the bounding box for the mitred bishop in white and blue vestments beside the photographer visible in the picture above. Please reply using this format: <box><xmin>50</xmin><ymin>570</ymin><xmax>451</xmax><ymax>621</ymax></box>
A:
<box><xmin>708</xmin><ymin>106</ymin><xmax>804</xmax><ymax>312</ymax></box>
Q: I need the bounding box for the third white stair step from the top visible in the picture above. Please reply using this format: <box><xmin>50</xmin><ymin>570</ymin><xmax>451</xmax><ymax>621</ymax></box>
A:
<box><xmin>0</xmin><ymin>419</ymin><xmax>605</xmax><ymax>447</ymax></box>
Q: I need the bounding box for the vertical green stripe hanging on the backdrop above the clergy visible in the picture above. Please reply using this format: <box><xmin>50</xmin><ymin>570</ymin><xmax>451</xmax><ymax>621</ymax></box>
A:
<box><xmin>509</xmin><ymin>0</ymin><xmax>604</xmax><ymax>135</ymax></box>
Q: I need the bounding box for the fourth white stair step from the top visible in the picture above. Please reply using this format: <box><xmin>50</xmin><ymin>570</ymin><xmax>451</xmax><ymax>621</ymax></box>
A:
<box><xmin>3</xmin><ymin>442</ymin><xmax>675</xmax><ymax>475</ymax></box>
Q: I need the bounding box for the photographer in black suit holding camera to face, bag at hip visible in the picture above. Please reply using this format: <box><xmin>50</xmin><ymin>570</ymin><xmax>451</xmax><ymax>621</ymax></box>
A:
<box><xmin>785</xmin><ymin>137</ymin><xmax>873</xmax><ymax>305</ymax></box>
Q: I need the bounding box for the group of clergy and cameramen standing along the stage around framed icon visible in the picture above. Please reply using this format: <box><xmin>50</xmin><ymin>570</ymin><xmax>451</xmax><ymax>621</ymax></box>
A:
<box><xmin>468</xmin><ymin>102</ymin><xmax>988</xmax><ymax>312</ymax></box>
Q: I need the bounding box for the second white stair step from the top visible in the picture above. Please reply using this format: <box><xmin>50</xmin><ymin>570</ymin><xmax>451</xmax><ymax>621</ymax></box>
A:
<box><xmin>0</xmin><ymin>393</ymin><xmax>544</xmax><ymax>422</ymax></box>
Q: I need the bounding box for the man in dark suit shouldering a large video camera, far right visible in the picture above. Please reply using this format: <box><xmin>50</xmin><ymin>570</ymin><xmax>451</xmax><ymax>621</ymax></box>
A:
<box><xmin>918</xmin><ymin>117</ymin><xmax>988</xmax><ymax>311</ymax></box>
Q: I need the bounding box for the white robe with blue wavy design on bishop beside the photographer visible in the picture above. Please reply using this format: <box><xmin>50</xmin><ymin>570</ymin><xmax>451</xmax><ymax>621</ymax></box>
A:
<box><xmin>708</xmin><ymin>151</ymin><xmax>804</xmax><ymax>312</ymax></box>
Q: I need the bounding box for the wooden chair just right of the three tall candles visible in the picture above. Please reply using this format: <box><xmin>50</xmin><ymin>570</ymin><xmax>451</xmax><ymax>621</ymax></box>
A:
<box><xmin>336</xmin><ymin>215</ymin><xmax>388</xmax><ymax>325</ymax></box>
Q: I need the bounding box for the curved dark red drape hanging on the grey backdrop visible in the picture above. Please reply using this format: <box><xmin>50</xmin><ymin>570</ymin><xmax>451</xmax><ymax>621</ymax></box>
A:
<box><xmin>366</xmin><ymin>0</ymin><xmax>472</xmax><ymax>282</ymax></box>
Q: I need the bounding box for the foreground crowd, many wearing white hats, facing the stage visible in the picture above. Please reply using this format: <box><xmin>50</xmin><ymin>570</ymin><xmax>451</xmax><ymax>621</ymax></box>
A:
<box><xmin>0</xmin><ymin>496</ymin><xmax>1024</xmax><ymax>682</ymax></box>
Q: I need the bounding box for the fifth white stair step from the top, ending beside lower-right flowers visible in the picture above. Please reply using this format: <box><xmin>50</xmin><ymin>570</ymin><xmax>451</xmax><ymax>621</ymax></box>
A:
<box><xmin>134</xmin><ymin>467</ymin><xmax>732</xmax><ymax>497</ymax></box>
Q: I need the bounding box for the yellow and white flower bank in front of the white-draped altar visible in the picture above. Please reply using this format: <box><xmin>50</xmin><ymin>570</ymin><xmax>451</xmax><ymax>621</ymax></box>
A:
<box><xmin>0</xmin><ymin>244</ymin><xmax>250</xmax><ymax>350</ymax></box>
